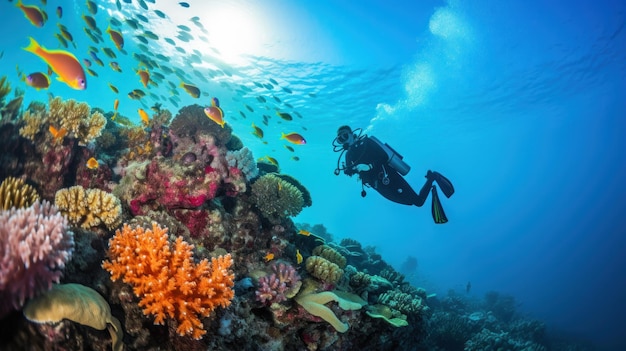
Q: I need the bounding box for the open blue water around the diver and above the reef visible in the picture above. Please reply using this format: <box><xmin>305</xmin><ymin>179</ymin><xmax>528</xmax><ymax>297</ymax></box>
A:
<box><xmin>0</xmin><ymin>0</ymin><xmax>626</xmax><ymax>350</ymax></box>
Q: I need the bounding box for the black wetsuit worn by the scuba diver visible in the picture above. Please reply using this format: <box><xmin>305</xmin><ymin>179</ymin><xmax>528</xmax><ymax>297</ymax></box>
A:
<box><xmin>344</xmin><ymin>135</ymin><xmax>433</xmax><ymax>207</ymax></box>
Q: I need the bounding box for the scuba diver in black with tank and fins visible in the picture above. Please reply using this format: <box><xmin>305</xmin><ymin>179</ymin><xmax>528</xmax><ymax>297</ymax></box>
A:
<box><xmin>333</xmin><ymin>125</ymin><xmax>454</xmax><ymax>224</ymax></box>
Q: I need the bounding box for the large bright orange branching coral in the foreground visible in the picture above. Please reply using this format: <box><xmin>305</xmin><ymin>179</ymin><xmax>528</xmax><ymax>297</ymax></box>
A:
<box><xmin>102</xmin><ymin>222</ymin><xmax>235</xmax><ymax>339</ymax></box>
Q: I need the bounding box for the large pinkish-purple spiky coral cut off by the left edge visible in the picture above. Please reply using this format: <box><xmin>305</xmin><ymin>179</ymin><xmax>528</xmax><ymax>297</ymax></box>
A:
<box><xmin>0</xmin><ymin>201</ymin><xmax>74</xmax><ymax>317</ymax></box>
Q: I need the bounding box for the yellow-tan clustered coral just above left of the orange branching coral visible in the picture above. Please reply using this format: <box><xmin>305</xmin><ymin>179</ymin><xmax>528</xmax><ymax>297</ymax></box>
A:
<box><xmin>54</xmin><ymin>185</ymin><xmax>122</xmax><ymax>229</ymax></box>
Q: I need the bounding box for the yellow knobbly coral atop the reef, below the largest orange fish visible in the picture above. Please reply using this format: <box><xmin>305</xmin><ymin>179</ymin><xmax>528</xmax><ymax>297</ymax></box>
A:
<box><xmin>48</xmin><ymin>97</ymin><xmax>107</xmax><ymax>144</ymax></box>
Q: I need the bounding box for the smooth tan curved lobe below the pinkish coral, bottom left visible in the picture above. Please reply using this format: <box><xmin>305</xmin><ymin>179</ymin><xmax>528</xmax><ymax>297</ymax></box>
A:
<box><xmin>24</xmin><ymin>284</ymin><xmax>124</xmax><ymax>351</ymax></box>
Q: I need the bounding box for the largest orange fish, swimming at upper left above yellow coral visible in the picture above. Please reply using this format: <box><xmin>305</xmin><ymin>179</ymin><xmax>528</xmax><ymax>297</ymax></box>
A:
<box><xmin>24</xmin><ymin>37</ymin><xmax>87</xmax><ymax>90</ymax></box>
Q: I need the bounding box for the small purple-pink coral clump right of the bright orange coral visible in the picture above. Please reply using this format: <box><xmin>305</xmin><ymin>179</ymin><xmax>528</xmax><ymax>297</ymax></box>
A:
<box><xmin>256</xmin><ymin>263</ymin><xmax>300</xmax><ymax>305</ymax></box>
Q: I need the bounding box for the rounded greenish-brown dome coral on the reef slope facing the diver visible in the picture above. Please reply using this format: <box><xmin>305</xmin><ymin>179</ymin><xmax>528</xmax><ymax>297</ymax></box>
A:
<box><xmin>250</xmin><ymin>174</ymin><xmax>304</xmax><ymax>223</ymax></box>
